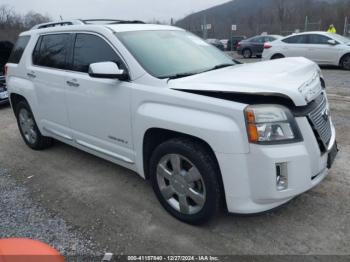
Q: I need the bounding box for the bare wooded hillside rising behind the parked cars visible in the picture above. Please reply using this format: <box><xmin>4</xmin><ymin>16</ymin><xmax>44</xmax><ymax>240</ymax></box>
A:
<box><xmin>176</xmin><ymin>0</ymin><xmax>350</xmax><ymax>39</ymax></box>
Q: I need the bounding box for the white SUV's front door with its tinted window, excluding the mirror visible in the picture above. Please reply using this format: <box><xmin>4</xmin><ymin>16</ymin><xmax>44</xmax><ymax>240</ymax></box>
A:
<box><xmin>65</xmin><ymin>33</ymin><xmax>134</xmax><ymax>163</ymax></box>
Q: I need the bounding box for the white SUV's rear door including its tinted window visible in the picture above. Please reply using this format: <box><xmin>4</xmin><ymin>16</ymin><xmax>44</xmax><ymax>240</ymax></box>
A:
<box><xmin>27</xmin><ymin>33</ymin><xmax>73</xmax><ymax>140</ymax></box>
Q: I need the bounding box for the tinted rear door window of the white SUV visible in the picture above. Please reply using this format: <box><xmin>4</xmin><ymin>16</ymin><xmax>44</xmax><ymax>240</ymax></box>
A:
<box><xmin>33</xmin><ymin>34</ymin><xmax>71</xmax><ymax>69</ymax></box>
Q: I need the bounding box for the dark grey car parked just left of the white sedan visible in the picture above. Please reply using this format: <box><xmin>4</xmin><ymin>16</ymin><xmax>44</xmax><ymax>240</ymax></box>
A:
<box><xmin>237</xmin><ymin>35</ymin><xmax>282</xmax><ymax>58</ymax></box>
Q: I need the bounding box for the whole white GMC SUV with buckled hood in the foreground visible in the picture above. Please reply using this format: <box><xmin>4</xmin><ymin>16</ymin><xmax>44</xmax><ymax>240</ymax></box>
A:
<box><xmin>7</xmin><ymin>20</ymin><xmax>337</xmax><ymax>224</ymax></box>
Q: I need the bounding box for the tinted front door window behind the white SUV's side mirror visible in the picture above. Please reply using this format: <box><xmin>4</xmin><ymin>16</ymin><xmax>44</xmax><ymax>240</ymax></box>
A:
<box><xmin>73</xmin><ymin>34</ymin><xmax>125</xmax><ymax>73</ymax></box>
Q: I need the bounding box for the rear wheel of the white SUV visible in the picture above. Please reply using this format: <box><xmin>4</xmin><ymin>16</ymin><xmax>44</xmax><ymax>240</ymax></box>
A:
<box><xmin>15</xmin><ymin>101</ymin><xmax>53</xmax><ymax>150</ymax></box>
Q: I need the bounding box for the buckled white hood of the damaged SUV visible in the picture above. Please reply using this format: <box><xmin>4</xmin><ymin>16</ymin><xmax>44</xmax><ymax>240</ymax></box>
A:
<box><xmin>169</xmin><ymin>57</ymin><xmax>322</xmax><ymax>106</ymax></box>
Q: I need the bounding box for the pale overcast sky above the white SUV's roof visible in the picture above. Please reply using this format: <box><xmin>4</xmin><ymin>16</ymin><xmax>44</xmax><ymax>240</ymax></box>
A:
<box><xmin>4</xmin><ymin>0</ymin><xmax>229</xmax><ymax>21</ymax></box>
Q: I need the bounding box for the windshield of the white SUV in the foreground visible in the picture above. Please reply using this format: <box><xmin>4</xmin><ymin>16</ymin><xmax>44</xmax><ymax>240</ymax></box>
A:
<box><xmin>116</xmin><ymin>30</ymin><xmax>235</xmax><ymax>78</ymax></box>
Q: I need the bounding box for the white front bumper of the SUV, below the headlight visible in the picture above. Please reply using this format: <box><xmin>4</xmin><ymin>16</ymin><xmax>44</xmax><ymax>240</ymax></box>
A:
<box><xmin>217</xmin><ymin>117</ymin><xmax>336</xmax><ymax>214</ymax></box>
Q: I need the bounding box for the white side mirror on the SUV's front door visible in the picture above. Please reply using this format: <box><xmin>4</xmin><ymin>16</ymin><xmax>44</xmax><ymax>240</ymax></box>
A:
<box><xmin>89</xmin><ymin>62</ymin><xmax>128</xmax><ymax>80</ymax></box>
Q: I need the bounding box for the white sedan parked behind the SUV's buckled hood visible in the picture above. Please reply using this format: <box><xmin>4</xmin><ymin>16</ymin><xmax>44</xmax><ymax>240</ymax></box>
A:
<box><xmin>263</xmin><ymin>32</ymin><xmax>350</xmax><ymax>70</ymax></box>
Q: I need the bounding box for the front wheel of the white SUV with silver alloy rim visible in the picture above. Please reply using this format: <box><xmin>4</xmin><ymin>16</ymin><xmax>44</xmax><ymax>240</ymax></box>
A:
<box><xmin>150</xmin><ymin>139</ymin><xmax>221</xmax><ymax>224</ymax></box>
